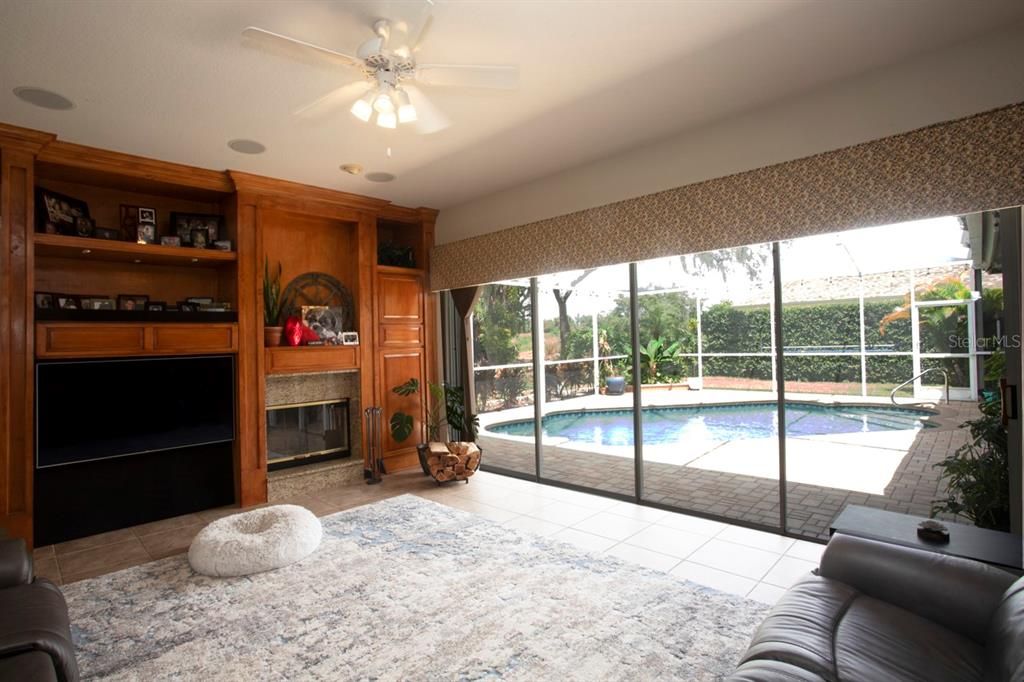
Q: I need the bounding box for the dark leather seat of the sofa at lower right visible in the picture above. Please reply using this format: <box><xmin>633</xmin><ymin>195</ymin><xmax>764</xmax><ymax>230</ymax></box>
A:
<box><xmin>730</xmin><ymin>576</ymin><xmax>984</xmax><ymax>681</ymax></box>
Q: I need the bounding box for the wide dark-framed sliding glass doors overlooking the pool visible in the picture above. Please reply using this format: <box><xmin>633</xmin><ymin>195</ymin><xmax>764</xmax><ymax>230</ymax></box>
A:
<box><xmin>472</xmin><ymin>212</ymin><xmax>1020</xmax><ymax>540</ymax></box>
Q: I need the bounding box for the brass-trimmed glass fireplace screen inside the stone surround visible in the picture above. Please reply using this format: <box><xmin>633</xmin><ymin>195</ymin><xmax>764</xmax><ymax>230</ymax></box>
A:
<box><xmin>266</xmin><ymin>400</ymin><xmax>351</xmax><ymax>470</ymax></box>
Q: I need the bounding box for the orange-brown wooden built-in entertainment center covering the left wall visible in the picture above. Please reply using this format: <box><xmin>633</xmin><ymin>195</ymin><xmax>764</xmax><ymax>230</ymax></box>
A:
<box><xmin>0</xmin><ymin>124</ymin><xmax>437</xmax><ymax>543</ymax></box>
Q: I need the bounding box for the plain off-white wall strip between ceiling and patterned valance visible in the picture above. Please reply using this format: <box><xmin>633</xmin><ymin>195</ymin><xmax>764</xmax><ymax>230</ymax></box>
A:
<box><xmin>436</xmin><ymin>20</ymin><xmax>1024</xmax><ymax>244</ymax></box>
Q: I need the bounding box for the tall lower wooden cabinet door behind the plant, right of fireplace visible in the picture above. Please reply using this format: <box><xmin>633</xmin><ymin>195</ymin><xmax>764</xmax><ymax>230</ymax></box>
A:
<box><xmin>378</xmin><ymin>348</ymin><xmax>427</xmax><ymax>464</ymax></box>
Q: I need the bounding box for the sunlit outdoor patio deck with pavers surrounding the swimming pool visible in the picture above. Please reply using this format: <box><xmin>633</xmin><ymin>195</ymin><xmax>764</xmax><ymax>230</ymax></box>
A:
<box><xmin>479</xmin><ymin>388</ymin><xmax>978</xmax><ymax>539</ymax></box>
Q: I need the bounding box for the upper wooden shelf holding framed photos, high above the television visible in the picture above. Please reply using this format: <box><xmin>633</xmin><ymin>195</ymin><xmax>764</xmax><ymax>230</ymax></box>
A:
<box><xmin>33</xmin><ymin>232</ymin><xmax>239</xmax><ymax>267</ymax></box>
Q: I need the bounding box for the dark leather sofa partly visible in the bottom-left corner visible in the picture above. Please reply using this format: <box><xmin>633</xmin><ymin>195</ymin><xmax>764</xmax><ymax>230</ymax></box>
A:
<box><xmin>0</xmin><ymin>538</ymin><xmax>79</xmax><ymax>682</ymax></box>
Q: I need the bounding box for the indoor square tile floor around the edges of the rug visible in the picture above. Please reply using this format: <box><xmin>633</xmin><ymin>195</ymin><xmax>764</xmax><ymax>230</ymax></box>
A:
<box><xmin>35</xmin><ymin>464</ymin><xmax>824</xmax><ymax>603</ymax></box>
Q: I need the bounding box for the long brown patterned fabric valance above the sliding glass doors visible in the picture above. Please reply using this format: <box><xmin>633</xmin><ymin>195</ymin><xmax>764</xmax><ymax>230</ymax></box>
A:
<box><xmin>431</xmin><ymin>102</ymin><xmax>1024</xmax><ymax>291</ymax></box>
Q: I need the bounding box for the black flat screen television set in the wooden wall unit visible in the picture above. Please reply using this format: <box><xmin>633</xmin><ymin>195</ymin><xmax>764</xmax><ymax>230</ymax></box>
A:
<box><xmin>36</xmin><ymin>355</ymin><xmax>234</xmax><ymax>468</ymax></box>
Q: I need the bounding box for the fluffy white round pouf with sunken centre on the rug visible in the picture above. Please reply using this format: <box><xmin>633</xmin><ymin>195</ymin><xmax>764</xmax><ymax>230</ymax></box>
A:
<box><xmin>188</xmin><ymin>505</ymin><xmax>324</xmax><ymax>577</ymax></box>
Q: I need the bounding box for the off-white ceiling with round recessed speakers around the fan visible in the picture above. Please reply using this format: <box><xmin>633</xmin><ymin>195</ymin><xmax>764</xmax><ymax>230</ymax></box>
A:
<box><xmin>0</xmin><ymin>0</ymin><xmax>1024</xmax><ymax>209</ymax></box>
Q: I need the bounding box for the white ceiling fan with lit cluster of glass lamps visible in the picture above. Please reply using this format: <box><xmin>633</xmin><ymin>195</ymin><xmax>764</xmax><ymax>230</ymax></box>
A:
<box><xmin>242</xmin><ymin>9</ymin><xmax>519</xmax><ymax>133</ymax></box>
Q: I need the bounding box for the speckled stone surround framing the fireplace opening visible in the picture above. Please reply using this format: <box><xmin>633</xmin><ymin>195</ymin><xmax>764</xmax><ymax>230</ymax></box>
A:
<box><xmin>266</xmin><ymin>370</ymin><xmax>362</xmax><ymax>503</ymax></box>
